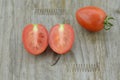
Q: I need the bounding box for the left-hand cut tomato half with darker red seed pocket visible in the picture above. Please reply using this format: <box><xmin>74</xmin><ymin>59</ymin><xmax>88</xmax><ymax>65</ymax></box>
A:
<box><xmin>22</xmin><ymin>24</ymin><xmax>48</xmax><ymax>55</ymax></box>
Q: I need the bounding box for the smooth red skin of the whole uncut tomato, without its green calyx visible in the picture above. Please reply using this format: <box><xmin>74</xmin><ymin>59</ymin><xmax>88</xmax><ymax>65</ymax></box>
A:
<box><xmin>76</xmin><ymin>6</ymin><xmax>106</xmax><ymax>32</ymax></box>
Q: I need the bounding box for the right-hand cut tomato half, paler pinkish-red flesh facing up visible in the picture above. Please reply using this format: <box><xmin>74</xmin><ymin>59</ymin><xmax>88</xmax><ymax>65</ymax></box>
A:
<box><xmin>49</xmin><ymin>24</ymin><xmax>74</xmax><ymax>54</ymax></box>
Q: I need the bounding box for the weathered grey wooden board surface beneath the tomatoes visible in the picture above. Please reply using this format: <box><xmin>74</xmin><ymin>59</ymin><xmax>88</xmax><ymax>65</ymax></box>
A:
<box><xmin>0</xmin><ymin>0</ymin><xmax>120</xmax><ymax>80</ymax></box>
